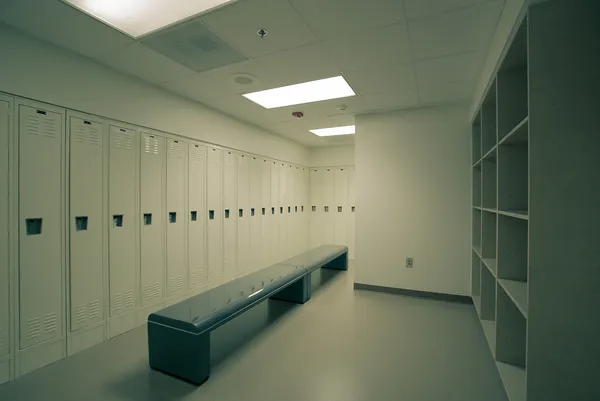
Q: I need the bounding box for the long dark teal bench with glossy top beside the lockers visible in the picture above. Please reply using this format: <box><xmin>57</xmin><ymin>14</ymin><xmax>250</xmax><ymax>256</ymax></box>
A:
<box><xmin>148</xmin><ymin>245</ymin><xmax>348</xmax><ymax>385</ymax></box>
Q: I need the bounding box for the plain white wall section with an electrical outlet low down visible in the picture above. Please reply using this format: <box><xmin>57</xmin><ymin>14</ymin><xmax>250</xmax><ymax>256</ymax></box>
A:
<box><xmin>355</xmin><ymin>104</ymin><xmax>471</xmax><ymax>295</ymax></box>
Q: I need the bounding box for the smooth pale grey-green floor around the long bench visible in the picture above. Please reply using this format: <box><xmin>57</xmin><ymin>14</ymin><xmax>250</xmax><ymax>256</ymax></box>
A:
<box><xmin>0</xmin><ymin>266</ymin><xmax>507</xmax><ymax>401</ymax></box>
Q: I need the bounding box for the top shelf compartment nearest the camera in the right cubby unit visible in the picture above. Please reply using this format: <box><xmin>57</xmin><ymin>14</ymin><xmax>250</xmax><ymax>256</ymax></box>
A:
<box><xmin>496</xmin><ymin>19</ymin><xmax>529</xmax><ymax>140</ymax></box>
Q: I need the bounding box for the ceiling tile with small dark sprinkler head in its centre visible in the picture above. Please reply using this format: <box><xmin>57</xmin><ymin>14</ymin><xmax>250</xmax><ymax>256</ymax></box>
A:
<box><xmin>201</xmin><ymin>0</ymin><xmax>317</xmax><ymax>58</ymax></box>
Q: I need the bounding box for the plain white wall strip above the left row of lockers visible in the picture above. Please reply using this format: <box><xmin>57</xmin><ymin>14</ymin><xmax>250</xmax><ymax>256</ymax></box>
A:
<box><xmin>0</xmin><ymin>24</ymin><xmax>309</xmax><ymax>165</ymax></box>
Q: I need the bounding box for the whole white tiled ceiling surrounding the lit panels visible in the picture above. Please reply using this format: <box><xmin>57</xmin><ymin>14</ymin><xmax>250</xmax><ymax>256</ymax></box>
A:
<box><xmin>0</xmin><ymin>0</ymin><xmax>504</xmax><ymax>147</ymax></box>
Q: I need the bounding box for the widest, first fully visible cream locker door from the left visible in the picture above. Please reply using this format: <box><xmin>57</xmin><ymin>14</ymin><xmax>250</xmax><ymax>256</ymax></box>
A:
<box><xmin>19</xmin><ymin>106</ymin><xmax>64</xmax><ymax>349</ymax></box>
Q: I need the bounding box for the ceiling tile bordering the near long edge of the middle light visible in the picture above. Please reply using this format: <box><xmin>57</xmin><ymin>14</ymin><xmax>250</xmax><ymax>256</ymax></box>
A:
<box><xmin>255</xmin><ymin>43</ymin><xmax>341</xmax><ymax>85</ymax></box>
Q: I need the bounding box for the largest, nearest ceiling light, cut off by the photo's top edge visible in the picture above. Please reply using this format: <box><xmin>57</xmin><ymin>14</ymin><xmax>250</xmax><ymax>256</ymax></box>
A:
<box><xmin>63</xmin><ymin>0</ymin><xmax>235</xmax><ymax>38</ymax></box>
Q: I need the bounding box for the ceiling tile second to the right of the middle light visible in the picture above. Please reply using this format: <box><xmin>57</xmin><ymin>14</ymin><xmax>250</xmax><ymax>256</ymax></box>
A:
<box><xmin>415</xmin><ymin>51</ymin><xmax>486</xmax><ymax>86</ymax></box>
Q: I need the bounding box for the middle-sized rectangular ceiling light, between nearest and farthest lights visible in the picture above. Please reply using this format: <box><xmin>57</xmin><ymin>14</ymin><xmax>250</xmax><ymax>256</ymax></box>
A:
<box><xmin>244</xmin><ymin>76</ymin><xmax>356</xmax><ymax>109</ymax></box>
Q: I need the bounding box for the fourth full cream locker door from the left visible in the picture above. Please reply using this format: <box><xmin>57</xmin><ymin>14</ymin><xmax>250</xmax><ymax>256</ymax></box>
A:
<box><xmin>140</xmin><ymin>132</ymin><xmax>166</xmax><ymax>306</ymax></box>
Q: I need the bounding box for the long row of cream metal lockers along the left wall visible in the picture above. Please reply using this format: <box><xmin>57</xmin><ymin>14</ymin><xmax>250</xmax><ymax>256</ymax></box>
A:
<box><xmin>0</xmin><ymin>97</ymin><xmax>309</xmax><ymax>383</ymax></box>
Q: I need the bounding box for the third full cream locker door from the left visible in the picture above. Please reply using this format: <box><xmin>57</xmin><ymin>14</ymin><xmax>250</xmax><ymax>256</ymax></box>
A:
<box><xmin>108</xmin><ymin>125</ymin><xmax>138</xmax><ymax>317</ymax></box>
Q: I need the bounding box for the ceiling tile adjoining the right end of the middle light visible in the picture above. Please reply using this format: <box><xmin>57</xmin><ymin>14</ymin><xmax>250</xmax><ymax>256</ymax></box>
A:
<box><xmin>346</xmin><ymin>63</ymin><xmax>417</xmax><ymax>95</ymax></box>
